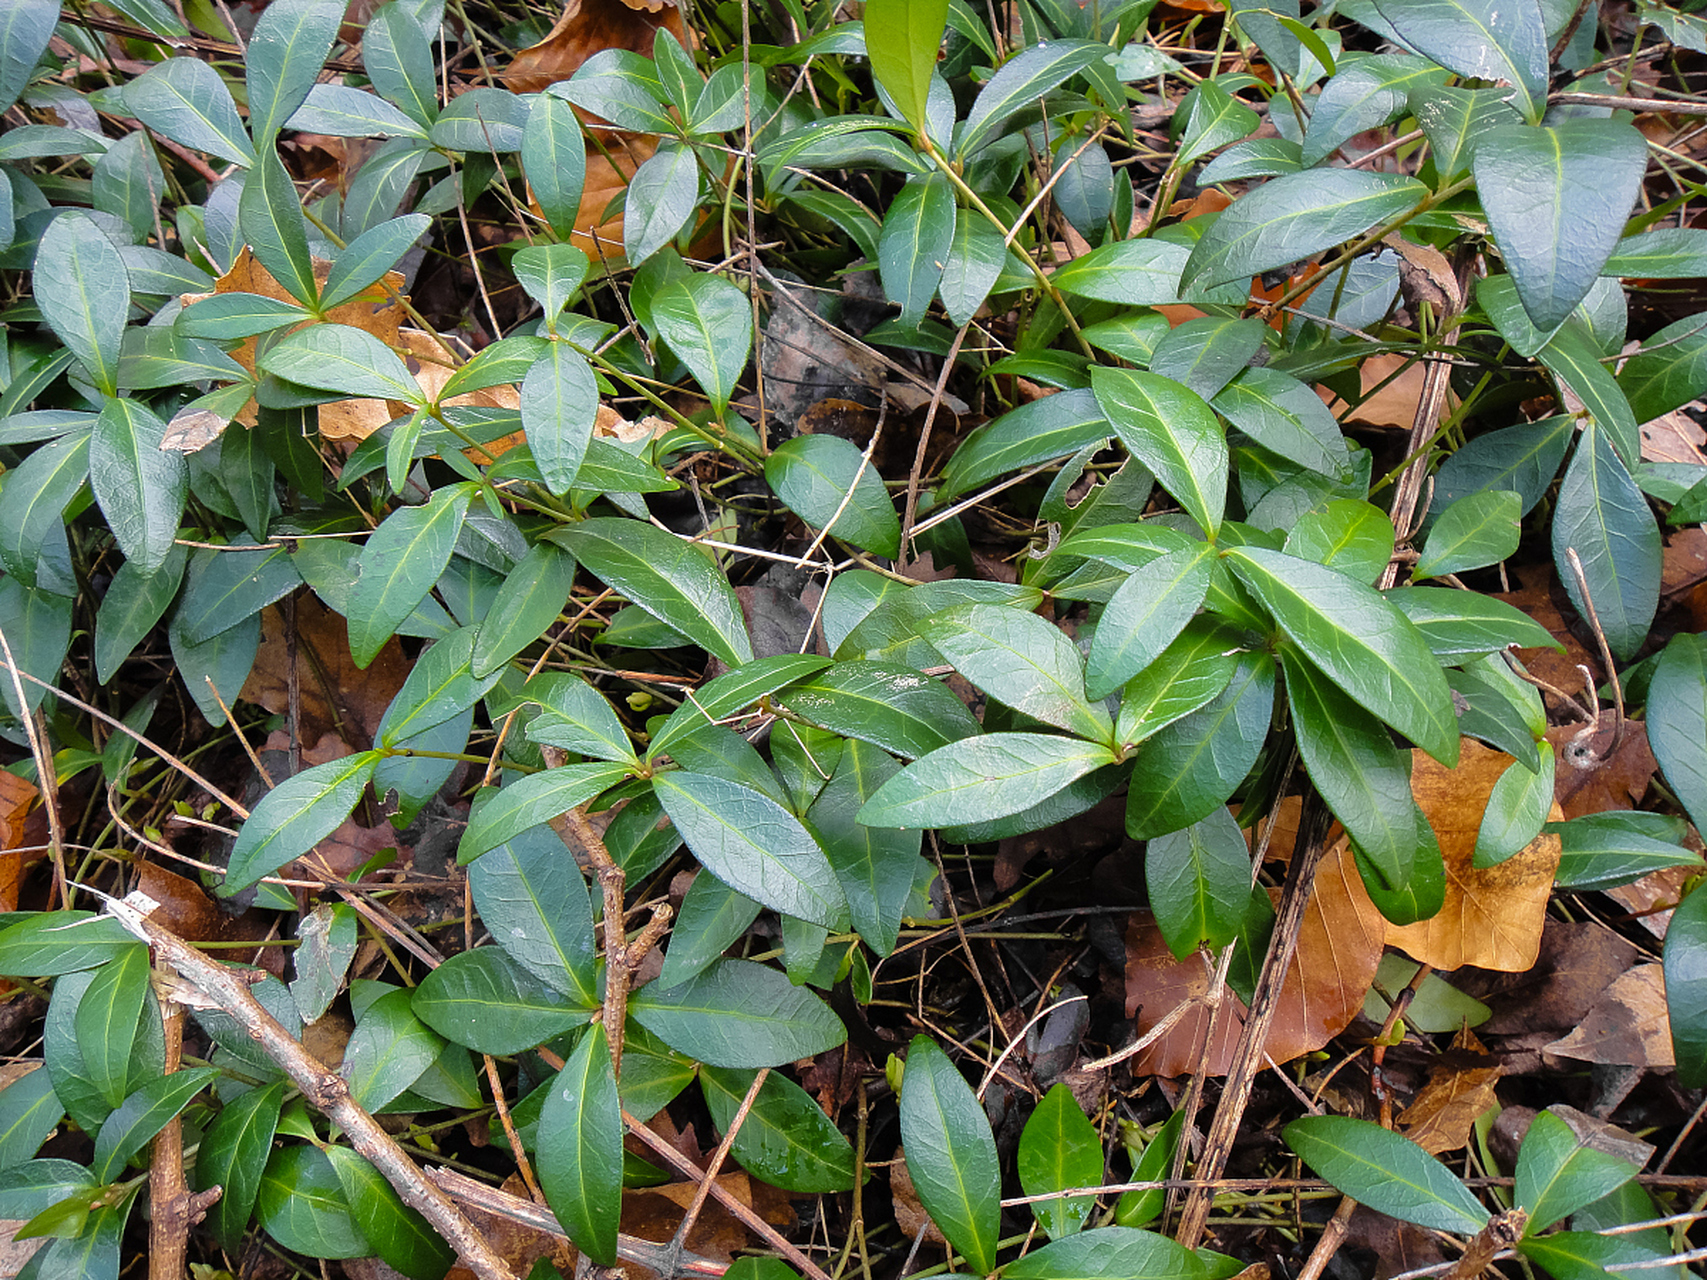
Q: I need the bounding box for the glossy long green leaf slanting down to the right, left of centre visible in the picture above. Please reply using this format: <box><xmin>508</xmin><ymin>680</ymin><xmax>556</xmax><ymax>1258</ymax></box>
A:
<box><xmin>550</xmin><ymin>517</ymin><xmax>753</xmax><ymax>667</ymax></box>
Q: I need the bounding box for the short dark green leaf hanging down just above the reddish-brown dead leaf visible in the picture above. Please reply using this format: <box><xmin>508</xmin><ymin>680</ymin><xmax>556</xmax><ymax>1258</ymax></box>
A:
<box><xmin>1147</xmin><ymin>807</ymin><xmax>1251</xmax><ymax>962</ymax></box>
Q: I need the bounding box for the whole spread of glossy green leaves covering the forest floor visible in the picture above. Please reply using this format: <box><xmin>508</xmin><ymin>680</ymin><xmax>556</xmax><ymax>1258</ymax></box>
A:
<box><xmin>0</xmin><ymin>0</ymin><xmax>1707</xmax><ymax>1280</ymax></box>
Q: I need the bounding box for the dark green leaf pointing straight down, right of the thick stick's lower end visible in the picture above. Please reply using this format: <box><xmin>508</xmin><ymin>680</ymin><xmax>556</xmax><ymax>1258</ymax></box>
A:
<box><xmin>538</xmin><ymin>1022</ymin><xmax>623</xmax><ymax>1266</ymax></box>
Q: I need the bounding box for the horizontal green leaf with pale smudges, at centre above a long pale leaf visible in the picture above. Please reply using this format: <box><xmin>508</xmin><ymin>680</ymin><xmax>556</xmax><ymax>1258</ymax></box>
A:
<box><xmin>775</xmin><ymin>662</ymin><xmax>978</xmax><ymax>759</ymax></box>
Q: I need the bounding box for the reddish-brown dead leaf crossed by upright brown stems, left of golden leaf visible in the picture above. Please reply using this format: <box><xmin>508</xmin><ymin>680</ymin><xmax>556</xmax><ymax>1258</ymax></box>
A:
<box><xmin>1127</xmin><ymin>836</ymin><xmax>1384</xmax><ymax>1077</ymax></box>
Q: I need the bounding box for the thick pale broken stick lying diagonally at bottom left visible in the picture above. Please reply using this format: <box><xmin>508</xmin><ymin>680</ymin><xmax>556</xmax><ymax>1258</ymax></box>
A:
<box><xmin>108</xmin><ymin>899</ymin><xmax>516</xmax><ymax>1280</ymax></box>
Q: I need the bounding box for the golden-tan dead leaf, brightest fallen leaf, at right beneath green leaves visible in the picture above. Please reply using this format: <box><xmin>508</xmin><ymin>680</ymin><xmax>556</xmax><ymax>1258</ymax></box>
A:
<box><xmin>1386</xmin><ymin>737</ymin><xmax>1564</xmax><ymax>973</ymax></box>
